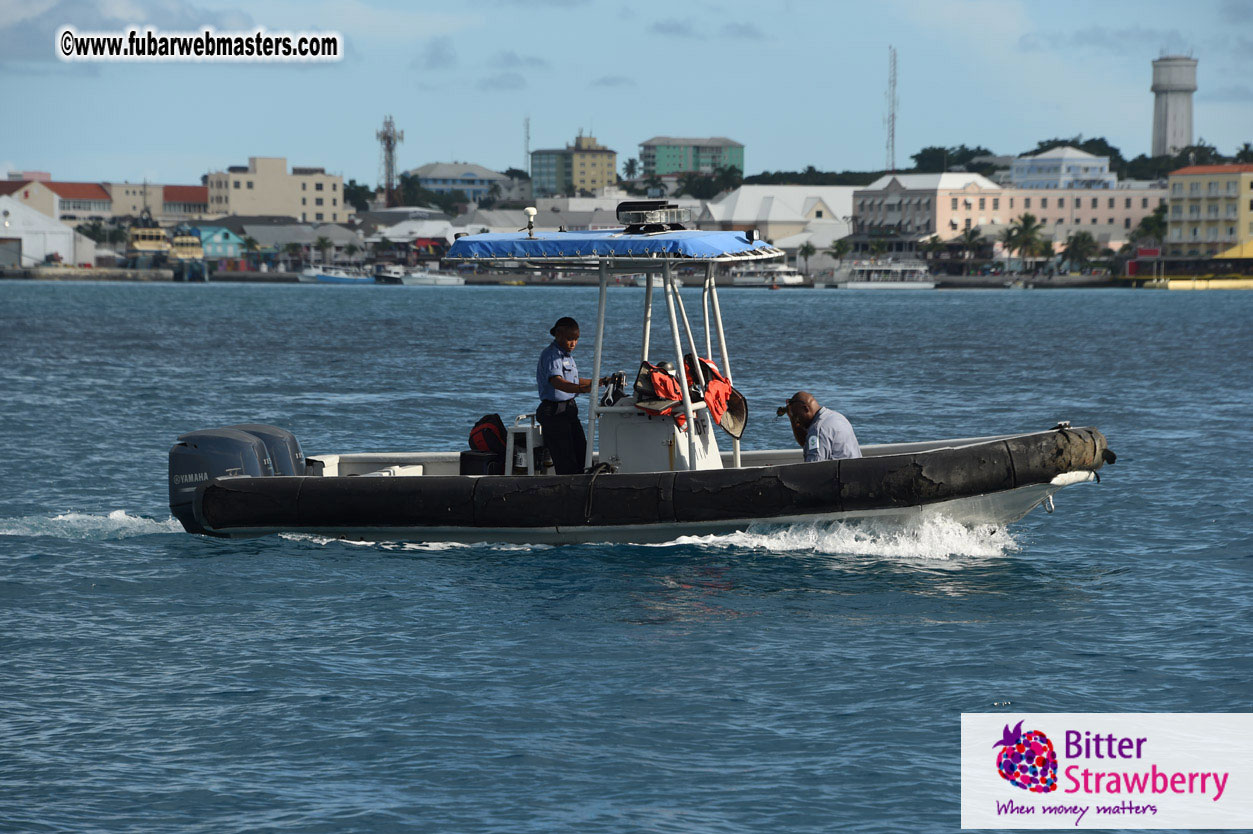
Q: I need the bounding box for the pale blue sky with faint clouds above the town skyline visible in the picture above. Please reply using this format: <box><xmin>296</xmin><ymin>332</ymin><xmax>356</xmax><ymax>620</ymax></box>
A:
<box><xmin>0</xmin><ymin>0</ymin><xmax>1253</xmax><ymax>184</ymax></box>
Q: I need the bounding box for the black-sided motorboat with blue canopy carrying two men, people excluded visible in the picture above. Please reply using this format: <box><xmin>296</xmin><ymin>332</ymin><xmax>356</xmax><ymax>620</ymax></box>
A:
<box><xmin>169</xmin><ymin>202</ymin><xmax>1114</xmax><ymax>543</ymax></box>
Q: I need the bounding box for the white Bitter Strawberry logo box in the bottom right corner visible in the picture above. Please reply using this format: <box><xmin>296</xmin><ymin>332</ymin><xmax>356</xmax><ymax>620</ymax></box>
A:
<box><xmin>961</xmin><ymin>713</ymin><xmax>1253</xmax><ymax>829</ymax></box>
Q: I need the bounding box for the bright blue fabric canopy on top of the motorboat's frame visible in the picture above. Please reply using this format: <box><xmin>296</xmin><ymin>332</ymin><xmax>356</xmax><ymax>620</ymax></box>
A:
<box><xmin>444</xmin><ymin>229</ymin><xmax>783</xmax><ymax>260</ymax></box>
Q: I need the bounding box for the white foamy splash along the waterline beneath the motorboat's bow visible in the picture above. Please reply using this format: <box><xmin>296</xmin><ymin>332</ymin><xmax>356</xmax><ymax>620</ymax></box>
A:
<box><xmin>654</xmin><ymin>517</ymin><xmax>1019</xmax><ymax>560</ymax></box>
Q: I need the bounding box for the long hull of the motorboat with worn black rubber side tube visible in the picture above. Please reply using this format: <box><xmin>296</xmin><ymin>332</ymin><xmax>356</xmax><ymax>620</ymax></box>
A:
<box><xmin>185</xmin><ymin>427</ymin><xmax>1113</xmax><ymax>543</ymax></box>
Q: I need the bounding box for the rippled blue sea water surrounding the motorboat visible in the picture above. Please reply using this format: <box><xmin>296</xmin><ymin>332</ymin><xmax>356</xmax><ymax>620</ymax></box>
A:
<box><xmin>0</xmin><ymin>282</ymin><xmax>1253</xmax><ymax>834</ymax></box>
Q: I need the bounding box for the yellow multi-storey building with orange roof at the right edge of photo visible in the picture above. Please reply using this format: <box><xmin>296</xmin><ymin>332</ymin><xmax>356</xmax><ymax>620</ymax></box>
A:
<box><xmin>1165</xmin><ymin>165</ymin><xmax>1253</xmax><ymax>252</ymax></box>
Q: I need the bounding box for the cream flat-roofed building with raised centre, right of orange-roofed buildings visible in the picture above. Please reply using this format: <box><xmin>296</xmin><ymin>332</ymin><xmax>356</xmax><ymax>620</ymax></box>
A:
<box><xmin>207</xmin><ymin>157</ymin><xmax>353</xmax><ymax>223</ymax></box>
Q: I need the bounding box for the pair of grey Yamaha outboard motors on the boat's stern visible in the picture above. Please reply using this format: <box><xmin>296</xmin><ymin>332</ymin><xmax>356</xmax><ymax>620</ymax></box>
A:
<box><xmin>169</xmin><ymin>423</ymin><xmax>304</xmax><ymax>535</ymax></box>
